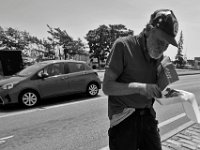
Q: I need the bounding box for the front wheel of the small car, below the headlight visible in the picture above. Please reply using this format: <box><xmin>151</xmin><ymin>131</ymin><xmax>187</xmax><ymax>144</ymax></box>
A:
<box><xmin>20</xmin><ymin>90</ymin><xmax>39</xmax><ymax>107</ymax></box>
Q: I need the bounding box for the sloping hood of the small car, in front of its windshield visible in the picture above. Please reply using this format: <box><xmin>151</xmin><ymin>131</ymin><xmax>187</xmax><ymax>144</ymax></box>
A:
<box><xmin>0</xmin><ymin>76</ymin><xmax>25</xmax><ymax>86</ymax></box>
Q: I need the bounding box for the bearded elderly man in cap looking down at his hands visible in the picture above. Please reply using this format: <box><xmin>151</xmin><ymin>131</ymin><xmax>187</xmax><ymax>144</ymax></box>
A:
<box><xmin>103</xmin><ymin>9</ymin><xmax>178</xmax><ymax>150</ymax></box>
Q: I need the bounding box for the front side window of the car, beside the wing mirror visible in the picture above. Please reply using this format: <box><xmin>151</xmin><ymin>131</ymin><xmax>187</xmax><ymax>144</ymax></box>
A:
<box><xmin>44</xmin><ymin>63</ymin><xmax>64</xmax><ymax>76</ymax></box>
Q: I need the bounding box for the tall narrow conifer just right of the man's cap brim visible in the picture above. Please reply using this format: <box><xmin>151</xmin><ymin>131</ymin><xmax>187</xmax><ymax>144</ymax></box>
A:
<box><xmin>175</xmin><ymin>31</ymin><xmax>186</xmax><ymax>68</ymax></box>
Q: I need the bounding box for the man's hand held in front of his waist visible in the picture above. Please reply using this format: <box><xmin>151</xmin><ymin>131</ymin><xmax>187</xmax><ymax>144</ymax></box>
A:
<box><xmin>138</xmin><ymin>83</ymin><xmax>162</xmax><ymax>98</ymax></box>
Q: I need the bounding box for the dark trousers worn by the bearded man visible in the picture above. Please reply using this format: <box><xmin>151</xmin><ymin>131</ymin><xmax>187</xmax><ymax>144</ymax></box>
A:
<box><xmin>108</xmin><ymin>109</ymin><xmax>162</xmax><ymax>150</ymax></box>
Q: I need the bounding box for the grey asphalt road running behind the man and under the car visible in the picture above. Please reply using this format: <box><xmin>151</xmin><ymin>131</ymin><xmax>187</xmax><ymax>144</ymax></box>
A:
<box><xmin>0</xmin><ymin>75</ymin><xmax>200</xmax><ymax>150</ymax></box>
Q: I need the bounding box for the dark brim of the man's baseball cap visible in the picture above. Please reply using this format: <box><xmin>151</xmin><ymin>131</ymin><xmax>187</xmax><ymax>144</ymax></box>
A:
<box><xmin>157</xmin><ymin>29</ymin><xmax>178</xmax><ymax>47</ymax></box>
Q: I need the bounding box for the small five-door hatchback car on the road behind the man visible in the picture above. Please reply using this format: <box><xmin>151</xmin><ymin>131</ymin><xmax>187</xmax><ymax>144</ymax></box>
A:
<box><xmin>0</xmin><ymin>60</ymin><xmax>101</xmax><ymax>107</ymax></box>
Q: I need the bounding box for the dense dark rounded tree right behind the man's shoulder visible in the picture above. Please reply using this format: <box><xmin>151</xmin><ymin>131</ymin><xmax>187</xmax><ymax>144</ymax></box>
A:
<box><xmin>85</xmin><ymin>24</ymin><xmax>133</xmax><ymax>65</ymax></box>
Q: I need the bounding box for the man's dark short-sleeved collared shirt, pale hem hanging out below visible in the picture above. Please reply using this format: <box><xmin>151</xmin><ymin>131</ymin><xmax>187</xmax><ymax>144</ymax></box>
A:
<box><xmin>106</xmin><ymin>33</ymin><xmax>160</xmax><ymax>126</ymax></box>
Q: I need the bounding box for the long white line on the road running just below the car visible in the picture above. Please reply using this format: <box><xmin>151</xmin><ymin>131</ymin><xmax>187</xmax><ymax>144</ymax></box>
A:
<box><xmin>0</xmin><ymin>96</ymin><xmax>107</xmax><ymax>118</ymax></box>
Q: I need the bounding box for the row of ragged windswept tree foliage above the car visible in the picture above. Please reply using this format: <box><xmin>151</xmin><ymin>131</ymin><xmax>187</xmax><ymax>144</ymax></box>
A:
<box><xmin>0</xmin><ymin>25</ymin><xmax>86</xmax><ymax>59</ymax></box>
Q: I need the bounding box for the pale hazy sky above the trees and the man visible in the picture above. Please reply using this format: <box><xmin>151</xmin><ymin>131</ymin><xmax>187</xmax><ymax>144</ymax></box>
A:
<box><xmin>0</xmin><ymin>0</ymin><xmax>200</xmax><ymax>59</ymax></box>
